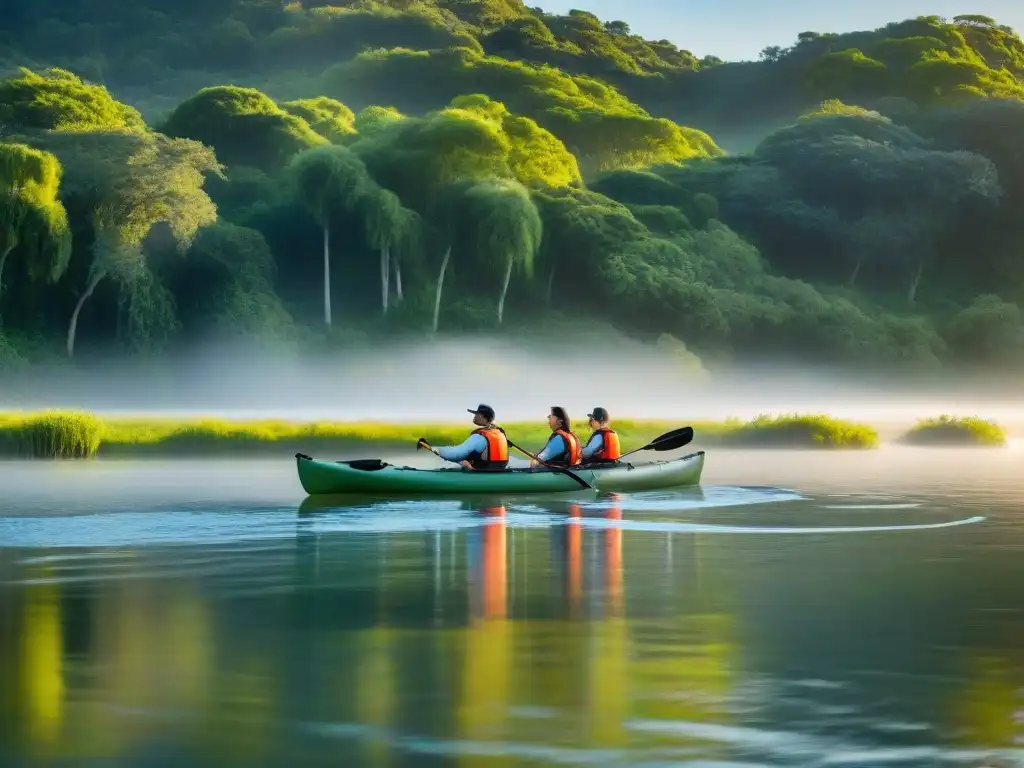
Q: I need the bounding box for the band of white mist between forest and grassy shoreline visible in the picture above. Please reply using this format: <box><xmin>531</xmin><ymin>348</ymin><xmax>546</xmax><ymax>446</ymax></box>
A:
<box><xmin>0</xmin><ymin>329</ymin><xmax>1024</xmax><ymax>434</ymax></box>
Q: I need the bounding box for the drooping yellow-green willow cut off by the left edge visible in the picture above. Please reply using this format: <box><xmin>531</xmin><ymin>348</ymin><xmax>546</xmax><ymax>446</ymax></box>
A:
<box><xmin>0</xmin><ymin>144</ymin><xmax>71</xmax><ymax>303</ymax></box>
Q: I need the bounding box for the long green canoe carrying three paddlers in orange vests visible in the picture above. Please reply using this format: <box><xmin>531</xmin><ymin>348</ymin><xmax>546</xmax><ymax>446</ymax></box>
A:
<box><xmin>295</xmin><ymin>451</ymin><xmax>705</xmax><ymax>496</ymax></box>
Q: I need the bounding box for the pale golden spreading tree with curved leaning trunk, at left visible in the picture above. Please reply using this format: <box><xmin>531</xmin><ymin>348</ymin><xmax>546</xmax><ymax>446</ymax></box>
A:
<box><xmin>39</xmin><ymin>131</ymin><xmax>221</xmax><ymax>356</ymax></box>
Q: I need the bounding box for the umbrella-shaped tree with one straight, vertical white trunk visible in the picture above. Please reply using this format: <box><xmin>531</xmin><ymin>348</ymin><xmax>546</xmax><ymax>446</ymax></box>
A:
<box><xmin>288</xmin><ymin>145</ymin><xmax>376</xmax><ymax>327</ymax></box>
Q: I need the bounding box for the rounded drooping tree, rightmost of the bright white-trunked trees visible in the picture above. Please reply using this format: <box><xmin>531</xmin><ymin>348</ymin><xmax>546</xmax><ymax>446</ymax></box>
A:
<box><xmin>465</xmin><ymin>179</ymin><xmax>543</xmax><ymax>323</ymax></box>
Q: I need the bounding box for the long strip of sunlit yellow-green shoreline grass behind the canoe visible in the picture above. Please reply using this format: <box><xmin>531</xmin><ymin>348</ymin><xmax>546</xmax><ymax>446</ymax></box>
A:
<box><xmin>0</xmin><ymin>411</ymin><xmax>1006</xmax><ymax>459</ymax></box>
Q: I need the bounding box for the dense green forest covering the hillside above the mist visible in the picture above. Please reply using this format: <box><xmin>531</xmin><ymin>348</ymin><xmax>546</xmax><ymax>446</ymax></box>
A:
<box><xmin>0</xmin><ymin>0</ymin><xmax>1024</xmax><ymax>373</ymax></box>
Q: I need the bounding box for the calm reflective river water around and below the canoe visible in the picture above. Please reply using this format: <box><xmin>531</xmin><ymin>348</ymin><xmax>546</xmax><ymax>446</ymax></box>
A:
<box><xmin>0</xmin><ymin>447</ymin><xmax>1024</xmax><ymax>768</ymax></box>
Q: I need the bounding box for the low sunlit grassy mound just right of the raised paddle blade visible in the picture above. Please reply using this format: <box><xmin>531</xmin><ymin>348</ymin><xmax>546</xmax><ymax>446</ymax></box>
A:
<box><xmin>723</xmin><ymin>415</ymin><xmax>879</xmax><ymax>449</ymax></box>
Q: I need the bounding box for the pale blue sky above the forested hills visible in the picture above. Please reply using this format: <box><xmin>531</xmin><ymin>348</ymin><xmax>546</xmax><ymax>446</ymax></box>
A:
<box><xmin>540</xmin><ymin>0</ymin><xmax>1024</xmax><ymax>60</ymax></box>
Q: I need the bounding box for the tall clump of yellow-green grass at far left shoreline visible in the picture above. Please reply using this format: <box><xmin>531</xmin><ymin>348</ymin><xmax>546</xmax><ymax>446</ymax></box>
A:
<box><xmin>0</xmin><ymin>411</ymin><xmax>104</xmax><ymax>459</ymax></box>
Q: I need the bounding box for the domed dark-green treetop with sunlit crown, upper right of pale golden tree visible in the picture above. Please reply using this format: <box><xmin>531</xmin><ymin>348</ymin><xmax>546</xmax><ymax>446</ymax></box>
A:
<box><xmin>160</xmin><ymin>85</ymin><xmax>323</xmax><ymax>171</ymax></box>
